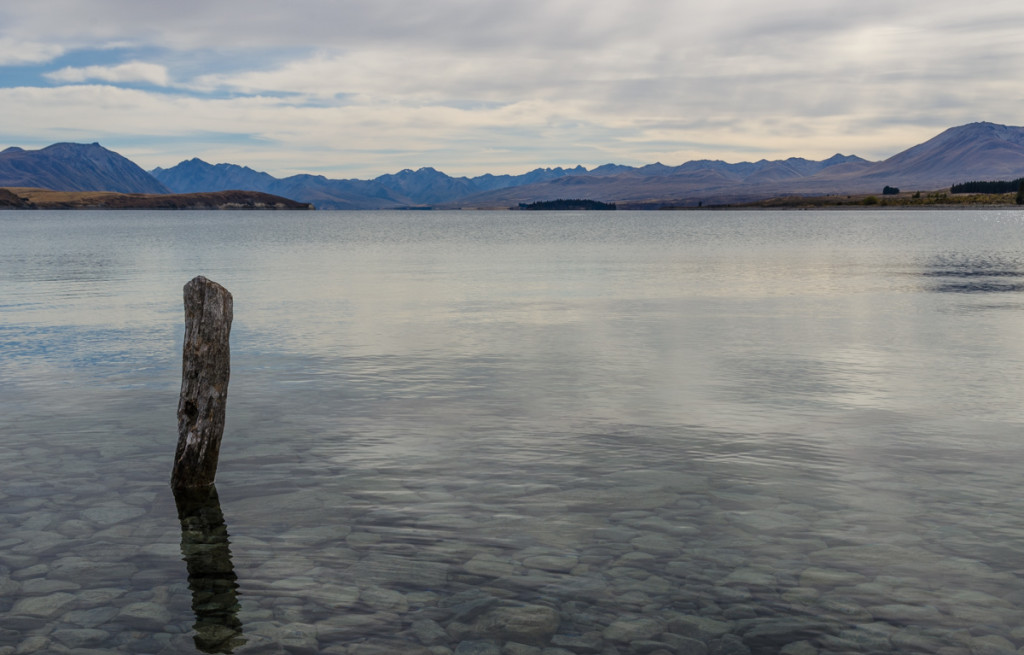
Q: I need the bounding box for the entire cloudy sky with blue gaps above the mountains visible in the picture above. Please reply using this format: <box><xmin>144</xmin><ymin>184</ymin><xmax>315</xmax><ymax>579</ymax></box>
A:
<box><xmin>0</xmin><ymin>0</ymin><xmax>1024</xmax><ymax>177</ymax></box>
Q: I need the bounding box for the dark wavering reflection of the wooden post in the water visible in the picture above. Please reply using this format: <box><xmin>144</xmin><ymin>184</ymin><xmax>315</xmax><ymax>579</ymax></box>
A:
<box><xmin>174</xmin><ymin>486</ymin><xmax>245</xmax><ymax>653</ymax></box>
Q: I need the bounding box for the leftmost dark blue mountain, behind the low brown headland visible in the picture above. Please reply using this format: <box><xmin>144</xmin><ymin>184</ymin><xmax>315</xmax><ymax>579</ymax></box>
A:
<box><xmin>0</xmin><ymin>143</ymin><xmax>169</xmax><ymax>193</ymax></box>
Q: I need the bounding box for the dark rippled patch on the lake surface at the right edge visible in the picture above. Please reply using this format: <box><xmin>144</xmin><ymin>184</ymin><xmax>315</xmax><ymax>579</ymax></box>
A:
<box><xmin>921</xmin><ymin>253</ymin><xmax>1024</xmax><ymax>294</ymax></box>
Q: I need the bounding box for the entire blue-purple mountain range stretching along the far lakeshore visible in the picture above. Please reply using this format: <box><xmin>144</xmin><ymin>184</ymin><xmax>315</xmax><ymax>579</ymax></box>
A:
<box><xmin>6</xmin><ymin>123</ymin><xmax>1024</xmax><ymax>209</ymax></box>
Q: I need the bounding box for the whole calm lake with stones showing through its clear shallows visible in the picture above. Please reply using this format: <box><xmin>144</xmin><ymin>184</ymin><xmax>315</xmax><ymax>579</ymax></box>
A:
<box><xmin>0</xmin><ymin>210</ymin><xmax>1024</xmax><ymax>655</ymax></box>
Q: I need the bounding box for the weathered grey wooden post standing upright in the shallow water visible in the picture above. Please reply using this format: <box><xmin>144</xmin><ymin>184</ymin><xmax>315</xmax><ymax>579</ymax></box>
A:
<box><xmin>171</xmin><ymin>275</ymin><xmax>232</xmax><ymax>489</ymax></box>
